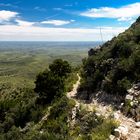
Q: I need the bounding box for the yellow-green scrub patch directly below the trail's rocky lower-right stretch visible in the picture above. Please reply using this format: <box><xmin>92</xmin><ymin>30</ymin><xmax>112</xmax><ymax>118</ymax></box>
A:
<box><xmin>70</xmin><ymin>105</ymin><xmax>118</xmax><ymax>140</ymax></box>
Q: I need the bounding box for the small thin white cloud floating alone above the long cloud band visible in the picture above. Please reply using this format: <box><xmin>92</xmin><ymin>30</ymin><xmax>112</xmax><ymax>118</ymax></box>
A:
<box><xmin>41</xmin><ymin>20</ymin><xmax>74</xmax><ymax>26</ymax></box>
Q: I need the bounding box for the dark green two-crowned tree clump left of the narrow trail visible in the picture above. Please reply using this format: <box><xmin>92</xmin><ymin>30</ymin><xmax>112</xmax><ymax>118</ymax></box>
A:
<box><xmin>35</xmin><ymin>59</ymin><xmax>71</xmax><ymax>103</ymax></box>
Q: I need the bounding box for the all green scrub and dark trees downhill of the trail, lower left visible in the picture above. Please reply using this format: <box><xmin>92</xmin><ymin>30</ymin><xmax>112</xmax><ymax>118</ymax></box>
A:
<box><xmin>0</xmin><ymin>59</ymin><xmax>117</xmax><ymax>140</ymax></box>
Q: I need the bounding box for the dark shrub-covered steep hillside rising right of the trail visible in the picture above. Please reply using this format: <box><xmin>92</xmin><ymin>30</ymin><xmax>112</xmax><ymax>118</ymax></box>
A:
<box><xmin>80</xmin><ymin>17</ymin><xmax>140</xmax><ymax>97</ymax></box>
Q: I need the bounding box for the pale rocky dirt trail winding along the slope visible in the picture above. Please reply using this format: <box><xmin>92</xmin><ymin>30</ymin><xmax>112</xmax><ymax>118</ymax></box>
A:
<box><xmin>67</xmin><ymin>74</ymin><xmax>140</xmax><ymax>140</ymax></box>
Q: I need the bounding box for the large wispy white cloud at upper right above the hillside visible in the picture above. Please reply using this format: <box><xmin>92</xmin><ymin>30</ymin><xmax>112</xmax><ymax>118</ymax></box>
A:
<box><xmin>80</xmin><ymin>2</ymin><xmax>140</xmax><ymax>21</ymax></box>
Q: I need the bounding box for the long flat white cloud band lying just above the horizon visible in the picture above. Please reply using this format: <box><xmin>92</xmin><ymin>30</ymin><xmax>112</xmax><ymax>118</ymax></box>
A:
<box><xmin>0</xmin><ymin>25</ymin><xmax>126</xmax><ymax>41</ymax></box>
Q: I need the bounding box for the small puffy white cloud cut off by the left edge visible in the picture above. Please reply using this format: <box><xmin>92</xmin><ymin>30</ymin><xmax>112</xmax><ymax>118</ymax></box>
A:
<box><xmin>0</xmin><ymin>10</ymin><xmax>18</xmax><ymax>22</ymax></box>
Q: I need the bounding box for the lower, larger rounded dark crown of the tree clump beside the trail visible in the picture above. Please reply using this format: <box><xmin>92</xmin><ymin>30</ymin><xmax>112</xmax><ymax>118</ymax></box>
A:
<box><xmin>35</xmin><ymin>71</ymin><xmax>64</xmax><ymax>102</ymax></box>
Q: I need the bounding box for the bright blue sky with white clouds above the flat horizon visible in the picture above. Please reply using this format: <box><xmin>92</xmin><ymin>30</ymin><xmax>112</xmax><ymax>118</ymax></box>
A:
<box><xmin>0</xmin><ymin>0</ymin><xmax>140</xmax><ymax>41</ymax></box>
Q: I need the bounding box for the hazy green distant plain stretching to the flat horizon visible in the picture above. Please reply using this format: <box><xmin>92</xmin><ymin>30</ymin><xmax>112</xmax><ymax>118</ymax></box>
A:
<box><xmin>0</xmin><ymin>42</ymin><xmax>101</xmax><ymax>87</ymax></box>
